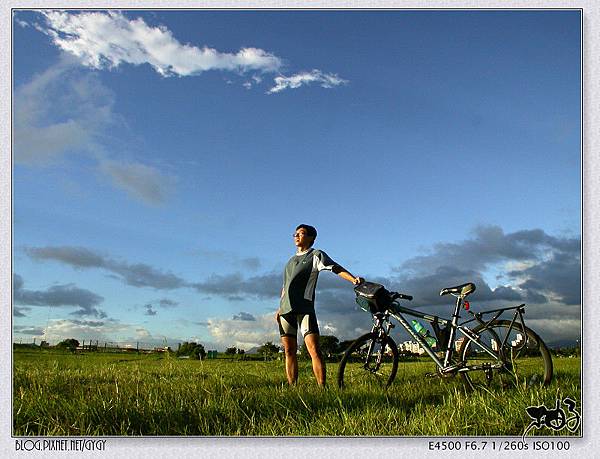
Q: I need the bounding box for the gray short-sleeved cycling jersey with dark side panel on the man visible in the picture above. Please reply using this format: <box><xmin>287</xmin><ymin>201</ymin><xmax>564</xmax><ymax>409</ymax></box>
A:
<box><xmin>279</xmin><ymin>248</ymin><xmax>343</xmax><ymax>314</ymax></box>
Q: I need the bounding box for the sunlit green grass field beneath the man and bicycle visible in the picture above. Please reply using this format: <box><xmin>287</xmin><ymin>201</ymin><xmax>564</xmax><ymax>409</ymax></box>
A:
<box><xmin>13</xmin><ymin>350</ymin><xmax>583</xmax><ymax>436</ymax></box>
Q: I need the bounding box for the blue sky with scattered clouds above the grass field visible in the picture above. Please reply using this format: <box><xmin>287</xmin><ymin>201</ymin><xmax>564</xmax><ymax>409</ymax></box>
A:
<box><xmin>13</xmin><ymin>10</ymin><xmax>581</xmax><ymax>349</ymax></box>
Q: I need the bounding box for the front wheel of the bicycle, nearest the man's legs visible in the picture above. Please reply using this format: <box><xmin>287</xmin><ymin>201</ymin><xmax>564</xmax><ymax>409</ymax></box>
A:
<box><xmin>338</xmin><ymin>333</ymin><xmax>398</xmax><ymax>389</ymax></box>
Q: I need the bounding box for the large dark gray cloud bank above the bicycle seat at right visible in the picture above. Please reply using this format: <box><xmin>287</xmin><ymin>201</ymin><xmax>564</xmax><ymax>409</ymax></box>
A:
<box><xmin>393</xmin><ymin>226</ymin><xmax>581</xmax><ymax>305</ymax></box>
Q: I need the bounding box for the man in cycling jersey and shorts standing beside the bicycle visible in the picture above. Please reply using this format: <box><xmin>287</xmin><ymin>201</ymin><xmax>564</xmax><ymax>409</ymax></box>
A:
<box><xmin>275</xmin><ymin>224</ymin><xmax>363</xmax><ymax>386</ymax></box>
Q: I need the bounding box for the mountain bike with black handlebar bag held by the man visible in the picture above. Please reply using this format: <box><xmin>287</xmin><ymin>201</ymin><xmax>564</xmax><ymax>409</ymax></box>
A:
<box><xmin>337</xmin><ymin>282</ymin><xmax>552</xmax><ymax>390</ymax></box>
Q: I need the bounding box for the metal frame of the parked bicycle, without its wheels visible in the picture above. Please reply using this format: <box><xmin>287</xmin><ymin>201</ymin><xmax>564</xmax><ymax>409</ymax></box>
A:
<box><xmin>380</xmin><ymin>296</ymin><xmax>528</xmax><ymax>373</ymax></box>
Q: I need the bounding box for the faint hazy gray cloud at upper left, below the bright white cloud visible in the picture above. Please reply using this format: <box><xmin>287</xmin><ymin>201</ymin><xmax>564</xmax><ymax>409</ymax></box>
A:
<box><xmin>13</xmin><ymin>56</ymin><xmax>175</xmax><ymax>205</ymax></box>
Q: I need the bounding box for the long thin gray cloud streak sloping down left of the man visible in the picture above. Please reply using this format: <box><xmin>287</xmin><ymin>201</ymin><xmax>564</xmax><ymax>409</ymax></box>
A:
<box><xmin>25</xmin><ymin>246</ymin><xmax>186</xmax><ymax>290</ymax></box>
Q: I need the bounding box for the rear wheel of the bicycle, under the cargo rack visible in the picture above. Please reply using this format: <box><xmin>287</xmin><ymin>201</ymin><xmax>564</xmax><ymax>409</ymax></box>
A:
<box><xmin>458</xmin><ymin>320</ymin><xmax>553</xmax><ymax>389</ymax></box>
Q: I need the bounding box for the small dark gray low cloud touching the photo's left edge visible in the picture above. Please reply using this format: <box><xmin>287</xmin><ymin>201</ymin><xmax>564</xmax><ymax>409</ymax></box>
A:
<box><xmin>13</xmin><ymin>274</ymin><xmax>105</xmax><ymax>317</ymax></box>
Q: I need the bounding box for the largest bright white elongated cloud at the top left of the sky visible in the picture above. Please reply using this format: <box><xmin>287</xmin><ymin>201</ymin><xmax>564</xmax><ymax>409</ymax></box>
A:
<box><xmin>43</xmin><ymin>11</ymin><xmax>282</xmax><ymax>76</ymax></box>
